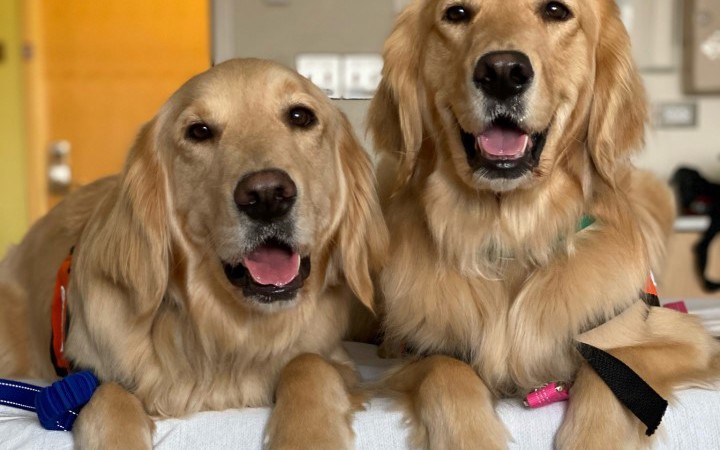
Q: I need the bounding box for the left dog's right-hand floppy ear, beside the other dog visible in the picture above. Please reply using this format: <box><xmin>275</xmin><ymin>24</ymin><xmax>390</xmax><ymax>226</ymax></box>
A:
<box><xmin>336</xmin><ymin>116</ymin><xmax>388</xmax><ymax>310</ymax></box>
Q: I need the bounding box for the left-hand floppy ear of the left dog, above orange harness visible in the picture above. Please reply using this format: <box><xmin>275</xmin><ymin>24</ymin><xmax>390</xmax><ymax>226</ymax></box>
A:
<box><xmin>74</xmin><ymin>121</ymin><xmax>170</xmax><ymax>316</ymax></box>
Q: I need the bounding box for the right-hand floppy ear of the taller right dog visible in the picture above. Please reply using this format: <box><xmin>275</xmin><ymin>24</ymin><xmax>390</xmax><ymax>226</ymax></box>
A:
<box><xmin>588</xmin><ymin>1</ymin><xmax>648</xmax><ymax>185</ymax></box>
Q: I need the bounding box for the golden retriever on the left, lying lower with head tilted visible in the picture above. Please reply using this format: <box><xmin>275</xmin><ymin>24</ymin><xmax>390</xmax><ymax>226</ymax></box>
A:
<box><xmin>0</xmin><ymin>59</ymin><xmax>387</xmax><ymax>449</ymax></box>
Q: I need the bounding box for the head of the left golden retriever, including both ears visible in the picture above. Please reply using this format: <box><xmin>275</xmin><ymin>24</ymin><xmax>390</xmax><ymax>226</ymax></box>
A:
<box><xmin>79</xmin><ymin>60</ymin><xmax>387</xmax><ymax>311</ymax></box>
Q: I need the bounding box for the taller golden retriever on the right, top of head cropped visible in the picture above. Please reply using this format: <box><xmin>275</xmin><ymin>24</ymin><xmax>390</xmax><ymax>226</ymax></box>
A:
<box><xmin>369</xmin><ymin>0</ymin><xmax>720</xmax><ymax>449</ymax></box>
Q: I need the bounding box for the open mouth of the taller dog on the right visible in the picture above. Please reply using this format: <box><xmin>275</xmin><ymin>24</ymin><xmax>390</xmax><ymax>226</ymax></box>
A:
<box><xmin>460</xmin><ymin>116</ymin><xmax>547</xmax><ymax>179</ymax></box>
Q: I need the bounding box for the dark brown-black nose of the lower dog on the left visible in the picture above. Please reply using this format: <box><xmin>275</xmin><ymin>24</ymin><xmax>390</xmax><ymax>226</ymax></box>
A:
<box><xmin>235</xmin><ymin>169</ymin><xmax>297</xmax><ymax>222</ymax></box>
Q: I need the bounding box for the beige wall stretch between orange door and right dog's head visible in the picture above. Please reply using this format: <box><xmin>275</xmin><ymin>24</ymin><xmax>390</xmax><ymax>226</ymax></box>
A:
<box><xmin>214</xmin><ymin>0</ymin><xmax>396</xmax><ymax>145</ymax></box>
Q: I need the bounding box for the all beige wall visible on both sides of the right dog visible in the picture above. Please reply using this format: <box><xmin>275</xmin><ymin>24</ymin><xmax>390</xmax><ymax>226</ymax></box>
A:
<box><xmin>215</xmin><ymin>0</ymin><xmax>720</xmax><ymax>180</ymax></box>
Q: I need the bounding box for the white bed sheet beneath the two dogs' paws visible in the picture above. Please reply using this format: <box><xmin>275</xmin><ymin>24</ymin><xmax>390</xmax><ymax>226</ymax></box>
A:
<box><xmin>0</xmin><ymin>343</ymin><xmax>720</xmax><ymax>450</ymax></box>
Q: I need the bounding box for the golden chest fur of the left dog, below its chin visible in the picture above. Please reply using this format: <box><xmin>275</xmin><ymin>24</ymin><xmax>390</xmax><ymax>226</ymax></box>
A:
<box><xmin>149</xmin><ymin>294</ymin><xmax>347</xmax><ymax>416</ymax></box>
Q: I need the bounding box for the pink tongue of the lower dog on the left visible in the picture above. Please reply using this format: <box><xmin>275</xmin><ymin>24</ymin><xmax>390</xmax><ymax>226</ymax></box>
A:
<box><xmin>243</xmin><ymin>244</ymin><xmax>300</xmax><ymax>286</ymax></box>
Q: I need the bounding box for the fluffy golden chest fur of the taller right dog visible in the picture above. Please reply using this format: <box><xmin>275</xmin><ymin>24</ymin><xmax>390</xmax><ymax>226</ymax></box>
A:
<box><xmin>381</xmin><ymin>178</ymin><xmax>612</xmax><ymax>395</ymax></box>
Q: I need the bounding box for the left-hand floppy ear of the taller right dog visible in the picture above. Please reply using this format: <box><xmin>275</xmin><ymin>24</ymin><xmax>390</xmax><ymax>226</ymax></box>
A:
<box><xmin>368</xmin><ymin>1</ymin><xmax>424</xmax><ymax>186</ymax></box>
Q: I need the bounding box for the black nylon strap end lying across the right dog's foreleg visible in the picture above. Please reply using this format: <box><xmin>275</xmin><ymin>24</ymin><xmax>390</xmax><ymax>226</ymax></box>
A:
<box><xmin>578</xmin><ymin>343</ymin><xmax>668</xmax><ymax>436</ymax></box>
